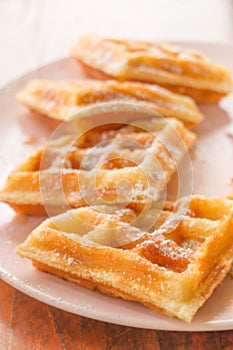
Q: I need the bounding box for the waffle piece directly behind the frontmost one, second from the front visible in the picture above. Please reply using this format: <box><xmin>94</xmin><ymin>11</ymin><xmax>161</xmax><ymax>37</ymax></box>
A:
<box><xmin>0</xmin><ymin>118</ymin><xmax>195</xmax><ymax>214</ymax></box>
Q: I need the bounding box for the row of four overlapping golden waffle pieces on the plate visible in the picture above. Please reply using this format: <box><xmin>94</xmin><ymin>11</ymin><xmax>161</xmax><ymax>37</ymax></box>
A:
<box><xmin>0</xmin><ymin>36</ymin><xmax>233</xmax><ymax>322</ymax></box>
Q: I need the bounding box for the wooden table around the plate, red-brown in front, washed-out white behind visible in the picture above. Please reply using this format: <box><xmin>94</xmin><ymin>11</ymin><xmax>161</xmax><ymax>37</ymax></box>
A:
<box><xmin>0</xmin><ymin>0</ymin><xmax>233</xmax><ymax>350</ymax></box>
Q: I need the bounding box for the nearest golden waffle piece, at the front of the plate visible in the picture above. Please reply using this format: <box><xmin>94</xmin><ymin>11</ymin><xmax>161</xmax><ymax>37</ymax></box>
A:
<box><xmin>17</xmin><ymin>196</ymin><xmax>233</xmax><ymax>322</ymax></box>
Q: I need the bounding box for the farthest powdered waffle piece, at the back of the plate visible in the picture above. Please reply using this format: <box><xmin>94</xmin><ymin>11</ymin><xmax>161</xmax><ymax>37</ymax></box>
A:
<box><xmin>72</xmin><ymin>36</ymin><xmax>233</xmax><ymax>102</ymax></box>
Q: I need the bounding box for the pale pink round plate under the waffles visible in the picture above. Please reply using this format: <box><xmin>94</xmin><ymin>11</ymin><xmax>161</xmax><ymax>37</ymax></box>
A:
<box><xmin>0</xmin><ymin>42</ymin><xmax>233</xmax><ymax>331</ymax></box>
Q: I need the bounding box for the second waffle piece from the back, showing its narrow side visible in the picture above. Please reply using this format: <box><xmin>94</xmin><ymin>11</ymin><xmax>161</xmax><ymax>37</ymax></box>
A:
<box><xmin>18</xmin><ymin>80</ymin><xmax>202</xmax><ymax>126</ymax></box>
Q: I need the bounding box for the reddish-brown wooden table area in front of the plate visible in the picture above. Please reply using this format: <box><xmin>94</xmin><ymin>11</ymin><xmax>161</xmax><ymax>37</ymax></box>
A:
<box><xmin>0</xmin><ymin>280</ymin><xmax>233</xmax><ymax>350</ymax></box>
